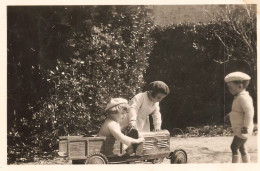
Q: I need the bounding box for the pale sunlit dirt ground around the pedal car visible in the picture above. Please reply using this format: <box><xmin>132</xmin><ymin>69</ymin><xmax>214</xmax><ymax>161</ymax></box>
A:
<box><xmin>14</xmin><ymin>136</ymin><xmax>257</xmax><ymax>165</ymax></box>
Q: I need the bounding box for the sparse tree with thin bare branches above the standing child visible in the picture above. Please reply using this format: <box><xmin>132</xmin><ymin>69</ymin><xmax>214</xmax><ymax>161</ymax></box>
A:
<box><xmin>203</xmin><ymin>4</ymin><xmax>257</xmax><ymax>91</ymax></box>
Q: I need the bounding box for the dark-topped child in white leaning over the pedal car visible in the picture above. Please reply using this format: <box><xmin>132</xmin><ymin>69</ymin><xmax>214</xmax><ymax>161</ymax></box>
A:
<box><xmin>121</xmin><ymin>81</ymin><xmax>170</xmax><ymax>132</ymax></box>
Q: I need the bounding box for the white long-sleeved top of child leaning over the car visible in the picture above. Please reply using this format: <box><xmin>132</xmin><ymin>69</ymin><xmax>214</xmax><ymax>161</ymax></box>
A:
<box><xmin>128</xmin><ymin>92</ymin><xmax>162</xmax><ymax>132</ymax></box>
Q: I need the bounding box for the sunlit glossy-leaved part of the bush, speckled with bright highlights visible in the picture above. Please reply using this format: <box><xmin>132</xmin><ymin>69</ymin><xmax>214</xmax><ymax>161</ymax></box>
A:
<box><xmin>21</xmin><ymin>6</ymin><xmax>153</xmax><ymax>157</ymax></box>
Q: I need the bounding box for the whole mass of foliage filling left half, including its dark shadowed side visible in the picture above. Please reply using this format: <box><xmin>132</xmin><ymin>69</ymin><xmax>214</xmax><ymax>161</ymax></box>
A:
<box><xmin>8</xmin><ymin>6</ymin><xmax>153</xmax><ymax>163</ymax></box>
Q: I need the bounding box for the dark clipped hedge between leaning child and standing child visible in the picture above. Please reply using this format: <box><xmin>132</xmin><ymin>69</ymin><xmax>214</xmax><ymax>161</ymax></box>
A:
<box><xmin>144</xmin><ymin>21</ymin><xmax>257</xmax><ymax>129</ymax></box>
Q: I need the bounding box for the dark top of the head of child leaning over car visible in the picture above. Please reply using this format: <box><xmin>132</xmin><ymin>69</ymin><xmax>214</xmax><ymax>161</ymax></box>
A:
<box><xmin>148</xmin><ymin>81</ymin><xmax>170</xmax><ymax>97</ymax></box>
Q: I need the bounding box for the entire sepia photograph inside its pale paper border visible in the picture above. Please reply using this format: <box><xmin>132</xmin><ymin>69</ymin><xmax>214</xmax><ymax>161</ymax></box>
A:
<box><xmin>6</xmin><ymin>4</ymin><xmax>258</xmax><ymax>165</ymax></box>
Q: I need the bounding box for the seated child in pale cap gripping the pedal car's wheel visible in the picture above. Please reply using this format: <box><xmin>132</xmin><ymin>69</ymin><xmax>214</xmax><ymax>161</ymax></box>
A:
<box><xmin>97</xmin><ymin>98</ymin><xmax>144</xmax><ymax>153</ymax></box>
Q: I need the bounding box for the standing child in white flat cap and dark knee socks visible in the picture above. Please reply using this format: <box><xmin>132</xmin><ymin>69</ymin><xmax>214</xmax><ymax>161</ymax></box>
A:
<box><xmin>225</xmin><ymin>72</ymin><xmax>254</xmax><ymax>163</ymax></box>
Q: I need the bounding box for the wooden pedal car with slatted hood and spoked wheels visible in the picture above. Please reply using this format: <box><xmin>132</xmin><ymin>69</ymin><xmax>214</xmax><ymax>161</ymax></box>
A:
<box><xmin>59</xmin><ymin>130</ymin><xmax>187</xmax><ymax>164</ymax></box>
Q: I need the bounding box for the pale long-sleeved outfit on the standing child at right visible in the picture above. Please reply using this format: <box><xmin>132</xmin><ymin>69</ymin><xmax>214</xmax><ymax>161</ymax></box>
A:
<box><xmin>229</xmin><ymin>90</ymin><xmax>254</xmax><ymax>138</ymax></box>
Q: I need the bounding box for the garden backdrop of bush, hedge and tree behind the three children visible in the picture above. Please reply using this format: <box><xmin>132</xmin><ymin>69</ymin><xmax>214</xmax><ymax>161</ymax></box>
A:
<box><xmin>7</xmin><ymin>5</ymin><xmax>257</xmax><ymax>164</ymax></box>
